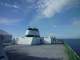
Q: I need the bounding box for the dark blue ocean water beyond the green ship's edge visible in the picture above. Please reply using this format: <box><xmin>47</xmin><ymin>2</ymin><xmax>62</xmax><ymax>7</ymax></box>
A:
<box><xmin>63</xmin><ymin>39</ymin><xmax>80</xmax><ymax>56</ymax></box>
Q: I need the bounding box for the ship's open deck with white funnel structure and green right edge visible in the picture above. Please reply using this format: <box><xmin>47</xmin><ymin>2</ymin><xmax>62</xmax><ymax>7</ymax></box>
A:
<box><xmin>0</xmin><ymin>28</ymin><xmax>80</xmax><ymax>60</ymax></box>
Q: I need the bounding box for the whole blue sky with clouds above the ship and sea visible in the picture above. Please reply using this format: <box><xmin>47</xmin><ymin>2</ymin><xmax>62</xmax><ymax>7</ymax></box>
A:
<box><xmin>0</xmin><ymin>0</ymin><xmax>80</xmax><ymax>38</ymax></box>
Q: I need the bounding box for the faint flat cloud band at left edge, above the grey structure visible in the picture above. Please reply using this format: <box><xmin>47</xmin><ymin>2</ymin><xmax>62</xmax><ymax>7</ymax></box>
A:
<box><xmin>0</xmin><ymin>18</ymin><xmax>21</xmax><ymax>25</ymax></box>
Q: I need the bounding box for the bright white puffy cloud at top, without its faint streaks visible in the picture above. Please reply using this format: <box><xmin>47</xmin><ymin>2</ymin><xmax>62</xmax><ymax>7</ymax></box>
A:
<box><xmin>38</xmin><ymin>0</ymin><xmax>70</xmax><ymax>17</ymax></box>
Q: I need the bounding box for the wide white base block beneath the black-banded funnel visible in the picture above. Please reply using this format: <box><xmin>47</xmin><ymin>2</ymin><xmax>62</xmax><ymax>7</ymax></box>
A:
<box><xmin>16</xmin><ymin>37</ymin><xmax>40</xmax><ymax>45</ymax></box>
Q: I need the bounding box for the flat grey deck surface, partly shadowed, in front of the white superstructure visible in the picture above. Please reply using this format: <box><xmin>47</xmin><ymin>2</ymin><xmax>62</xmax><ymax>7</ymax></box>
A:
<box><xmin>5</xmin><ymin>44</ymin><xmax>68</xmax><ymax>60</ymax></box>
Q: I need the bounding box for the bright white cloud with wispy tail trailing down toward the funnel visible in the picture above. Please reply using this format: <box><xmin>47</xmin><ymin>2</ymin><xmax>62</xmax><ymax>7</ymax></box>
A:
<box><xmin>30</xmin><ymin>0</ymin><xmax>70</xmax><ymax>27</ymax></box>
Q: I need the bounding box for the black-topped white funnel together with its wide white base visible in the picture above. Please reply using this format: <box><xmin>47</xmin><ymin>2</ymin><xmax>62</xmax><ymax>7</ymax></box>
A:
<box><xmin>17</xmin><ymin>28</ymin><xmax>40</xmax><ymax>45</ymax></box>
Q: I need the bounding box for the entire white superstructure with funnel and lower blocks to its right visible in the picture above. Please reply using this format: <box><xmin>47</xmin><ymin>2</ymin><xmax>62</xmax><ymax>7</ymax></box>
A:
<box><xmin>16</xmin><ymin>28</ymin><xmax>62</xmax><ymax>45</ymax></box>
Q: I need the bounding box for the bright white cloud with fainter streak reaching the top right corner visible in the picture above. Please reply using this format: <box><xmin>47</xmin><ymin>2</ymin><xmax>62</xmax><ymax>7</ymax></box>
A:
<box><xmin>36</xmin><ymin>0</ymin><xmax>80</xmax><ymax>17</ymax></box>
